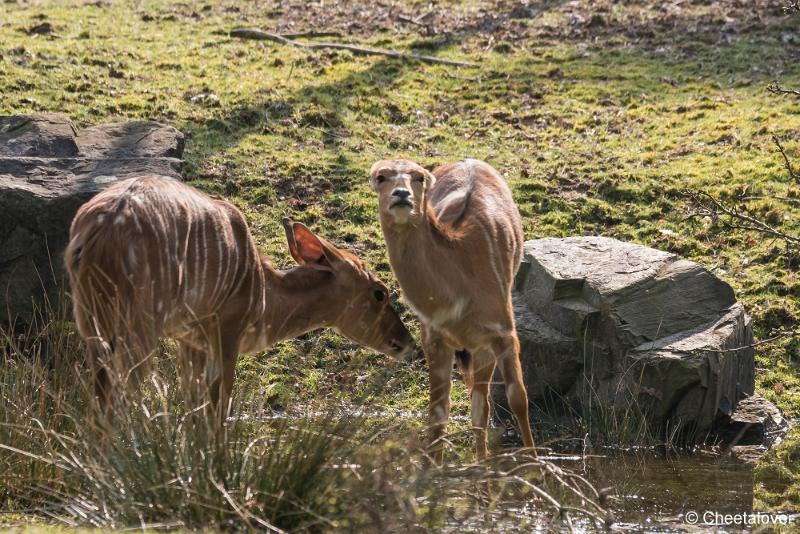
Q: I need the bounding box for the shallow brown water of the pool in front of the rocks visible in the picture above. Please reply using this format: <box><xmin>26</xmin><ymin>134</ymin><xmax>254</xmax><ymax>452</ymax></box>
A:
<box><xmin>244</xmin><ymin>411</ymin><xmax>800</xmax><ymax>533</ymax></box>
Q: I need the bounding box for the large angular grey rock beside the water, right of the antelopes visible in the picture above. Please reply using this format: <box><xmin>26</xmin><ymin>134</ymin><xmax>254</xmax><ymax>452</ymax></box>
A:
<box><xmin>495</xmin><ymin>237</ymin><xmax>755</xmax><ymax>438</ymax></box>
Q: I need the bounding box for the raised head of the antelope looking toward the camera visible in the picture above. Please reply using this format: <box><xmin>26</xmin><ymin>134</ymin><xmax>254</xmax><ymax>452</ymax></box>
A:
<box><xmin>369</xmin><ymin>159</ymin><xmax>436</xmax><ymax>225</ymax></box>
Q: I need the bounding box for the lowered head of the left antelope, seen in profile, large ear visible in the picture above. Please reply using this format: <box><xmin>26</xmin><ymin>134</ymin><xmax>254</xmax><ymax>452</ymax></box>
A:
<box><xmin>283</xmin><ymin>219</ymin><xmax>416</xmax><ymax>359</ymax></box>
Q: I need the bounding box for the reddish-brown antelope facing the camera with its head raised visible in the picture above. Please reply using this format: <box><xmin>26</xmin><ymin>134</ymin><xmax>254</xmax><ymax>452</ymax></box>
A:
<box><xmin>370</xmin><ymin>159</ymin><xmax>536</xmax><ymax>463</ymax></box>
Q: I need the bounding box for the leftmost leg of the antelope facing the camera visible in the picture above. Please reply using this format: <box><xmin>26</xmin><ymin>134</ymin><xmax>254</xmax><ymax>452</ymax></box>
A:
<box><xmin>422</xmin><ymin>327</ymin><xmax>454</xmax><ymax>465</ymax></box>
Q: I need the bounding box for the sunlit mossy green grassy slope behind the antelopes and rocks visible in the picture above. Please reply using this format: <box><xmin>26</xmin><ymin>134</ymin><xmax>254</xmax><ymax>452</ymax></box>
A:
<box><xmin>0</xmin><ymin>0</ymin><xmax>800</xmax><ymax>508</ymax></box>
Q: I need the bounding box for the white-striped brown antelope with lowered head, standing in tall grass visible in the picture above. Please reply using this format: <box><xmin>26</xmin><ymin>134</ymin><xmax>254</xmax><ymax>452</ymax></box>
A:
<box><xmin>65</xmin><ymin>176</ymin><xmax>414</xmax><ymax>422</ymax></box>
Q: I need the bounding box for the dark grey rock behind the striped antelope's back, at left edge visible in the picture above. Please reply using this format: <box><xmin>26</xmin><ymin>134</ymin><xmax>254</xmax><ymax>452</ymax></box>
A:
<box><xmin>0</xmin><ymin>115</ymin><xmax>184</xmax><ymax>323</ymax></box>
